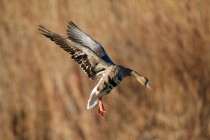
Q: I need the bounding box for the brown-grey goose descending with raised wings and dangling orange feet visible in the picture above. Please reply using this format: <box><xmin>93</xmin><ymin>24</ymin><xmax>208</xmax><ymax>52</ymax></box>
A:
<box><xmin>39</xmin><ymin>21</ymin><xmax>151</xmax><ymax>118</ymax></box>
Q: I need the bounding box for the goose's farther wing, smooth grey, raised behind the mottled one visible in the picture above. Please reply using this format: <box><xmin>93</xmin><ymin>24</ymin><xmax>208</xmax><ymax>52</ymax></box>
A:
<box><xmin>66</xmin><ymin>21</ymin><xmax>113</xmax><ymax>64</ymax></box>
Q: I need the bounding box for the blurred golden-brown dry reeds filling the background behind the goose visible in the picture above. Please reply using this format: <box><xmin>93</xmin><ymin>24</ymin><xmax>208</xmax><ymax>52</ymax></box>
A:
<box><xmin>0</xmin><ymin>0</ymin><xmax>210</xmax><ymax>140</ymax></box>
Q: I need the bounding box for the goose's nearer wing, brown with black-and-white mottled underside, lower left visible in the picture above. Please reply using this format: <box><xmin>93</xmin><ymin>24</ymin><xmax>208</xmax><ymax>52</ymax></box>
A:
<box><xmin>39</xmin><ymin>25</ymin><xmax>110</xmax><ymax>80</ymax></box>
